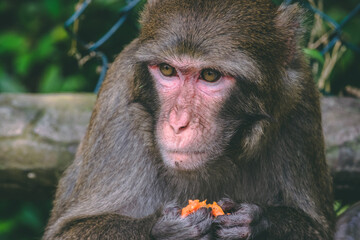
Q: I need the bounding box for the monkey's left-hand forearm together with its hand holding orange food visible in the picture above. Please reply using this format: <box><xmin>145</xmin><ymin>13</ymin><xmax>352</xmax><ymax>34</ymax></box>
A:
<box><xmin>43</xmin><ymin>205</ymin><xmax>212</xmax><ymax>240</ymax></box>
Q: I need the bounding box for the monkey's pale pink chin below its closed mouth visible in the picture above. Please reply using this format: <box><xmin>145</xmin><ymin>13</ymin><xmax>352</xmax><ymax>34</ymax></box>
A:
<box><xmin>162</xmin><ymin>151</ymin><xmax>207</xmax><ymax>171</ymax></box>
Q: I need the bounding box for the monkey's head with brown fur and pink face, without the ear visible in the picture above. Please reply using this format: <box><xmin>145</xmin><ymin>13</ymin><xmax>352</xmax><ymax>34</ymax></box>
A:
<box><xmin>136</xmin><ymin>0</ymin><xmax>285</xmax><ymax>170</ymax></box>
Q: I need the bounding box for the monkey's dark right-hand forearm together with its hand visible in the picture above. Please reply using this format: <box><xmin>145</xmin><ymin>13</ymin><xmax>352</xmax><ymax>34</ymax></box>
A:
<box><xmin>215</xmin><ymin>199</ymin><xmax>332</xmax><ymax>240</ymax></box>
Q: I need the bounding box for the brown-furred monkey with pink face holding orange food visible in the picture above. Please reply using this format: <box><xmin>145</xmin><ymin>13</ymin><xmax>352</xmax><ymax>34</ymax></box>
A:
<box><xmin>43</xmin><ymin>0</ymin><xmax>334</xmax><ymax>240</ymax></box>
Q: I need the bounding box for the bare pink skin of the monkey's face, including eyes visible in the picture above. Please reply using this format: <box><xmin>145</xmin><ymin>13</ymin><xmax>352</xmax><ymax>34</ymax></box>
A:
<box><xmin>148</xmin><ymin>59</ymin><xmax>235</xmax><ymax>170</ymax></box>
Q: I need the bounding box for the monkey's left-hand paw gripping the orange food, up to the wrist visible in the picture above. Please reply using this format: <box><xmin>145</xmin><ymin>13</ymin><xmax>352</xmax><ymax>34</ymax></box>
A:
<box><xmin>151</xmin><ymin>205</ymin><xmax>213</xmax><ymax>240</ymax></box>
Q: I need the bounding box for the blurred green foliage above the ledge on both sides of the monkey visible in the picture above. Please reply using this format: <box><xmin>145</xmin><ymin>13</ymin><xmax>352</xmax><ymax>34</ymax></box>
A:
<box><xmin>0</xmin><ymin>0</ymin><xmax>360</xmax><ymax>94</ymax></box>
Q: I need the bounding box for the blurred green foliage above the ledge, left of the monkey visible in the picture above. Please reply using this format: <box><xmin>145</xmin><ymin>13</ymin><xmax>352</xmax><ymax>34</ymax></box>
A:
<box><xmin>0</xmin><ymin>0</ymin><xmax>141</xmax><ymax>93</ymax></box>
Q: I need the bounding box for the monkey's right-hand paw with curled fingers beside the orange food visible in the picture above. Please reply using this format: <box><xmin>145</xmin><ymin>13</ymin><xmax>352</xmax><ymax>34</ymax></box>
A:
<box><xmin>215</xmin><ymin>199</ymin><xmax>269</xmax><ymax>239</ymax></box>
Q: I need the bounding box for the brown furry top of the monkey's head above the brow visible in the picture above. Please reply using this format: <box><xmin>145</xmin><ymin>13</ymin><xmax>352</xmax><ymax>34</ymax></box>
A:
<box><xmin>139</xmin><ymin>0</ymin><xmax>284</xmax><ymax>67</ymax></box>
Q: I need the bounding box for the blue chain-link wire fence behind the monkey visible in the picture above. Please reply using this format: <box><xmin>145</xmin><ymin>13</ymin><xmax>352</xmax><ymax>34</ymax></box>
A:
<box><xmin>64</xmin><ymin>0</ymin><xmax>360</xmax><ymax>93</ymax></box>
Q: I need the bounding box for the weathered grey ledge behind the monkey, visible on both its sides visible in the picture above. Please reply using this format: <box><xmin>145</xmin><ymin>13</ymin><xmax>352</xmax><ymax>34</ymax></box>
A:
<box><xmin>0</xmin><ymin>94</ymin><xmax>360</xmax><ymax>200</ymax></box>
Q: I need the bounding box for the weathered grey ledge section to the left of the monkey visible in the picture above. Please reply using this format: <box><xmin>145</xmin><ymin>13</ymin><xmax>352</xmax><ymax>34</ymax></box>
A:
<box><xmin>0</xmin><ymin>94</ymin><xmax>96</xmax><ymax>198</ymax></box>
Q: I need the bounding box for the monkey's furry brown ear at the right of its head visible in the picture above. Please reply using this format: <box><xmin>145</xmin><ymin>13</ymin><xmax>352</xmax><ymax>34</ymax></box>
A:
<box><xmin>276</xmin><ymin>3</ymin><xmax>306</xmax><ymax>65</ymax></box>
